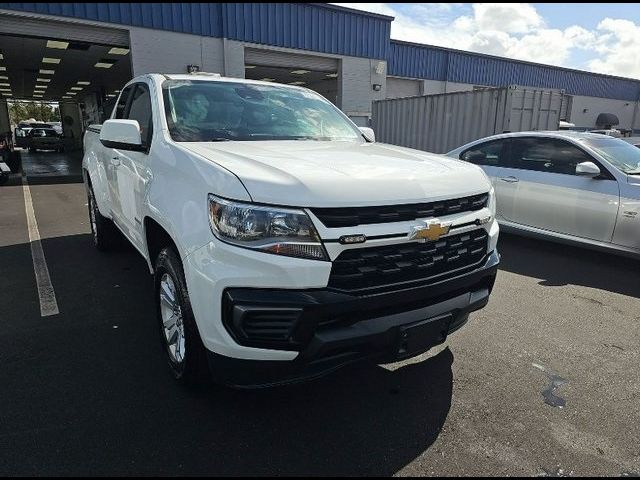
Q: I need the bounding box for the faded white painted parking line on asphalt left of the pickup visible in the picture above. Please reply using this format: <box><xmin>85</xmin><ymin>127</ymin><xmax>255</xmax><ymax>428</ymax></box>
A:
<box><xmin>22</xmin><ymin>174</ymin><xmax>60</xmax><ymax>317</ymax></box>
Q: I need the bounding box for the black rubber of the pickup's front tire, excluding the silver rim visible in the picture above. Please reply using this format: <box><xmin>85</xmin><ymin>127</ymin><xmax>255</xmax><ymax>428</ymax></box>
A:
<box><xmin>154</xmin><ymin>247</ymin><xmax>211</xmax><ymax>387</ymax></box>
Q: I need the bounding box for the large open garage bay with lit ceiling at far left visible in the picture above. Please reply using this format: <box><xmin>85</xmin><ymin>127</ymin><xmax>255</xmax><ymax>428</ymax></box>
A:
<box><xmin>0</xmin><ymin>13</ymin><xmax>132</xmax><ymax>181</ymax></box>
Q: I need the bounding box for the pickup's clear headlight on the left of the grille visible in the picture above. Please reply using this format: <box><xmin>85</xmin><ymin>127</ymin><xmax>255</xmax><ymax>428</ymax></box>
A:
<box><xmin>209</xmin><ymin>194</ymin><xmax>328</xmax><ymax>260</ymax></box>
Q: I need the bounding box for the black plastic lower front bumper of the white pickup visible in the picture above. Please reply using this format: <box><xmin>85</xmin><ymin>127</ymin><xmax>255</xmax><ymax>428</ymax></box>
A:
<box><xmin>209</xmin><ymin>251</ymin><xmax>499</xmax><ymax>387</ymax></box>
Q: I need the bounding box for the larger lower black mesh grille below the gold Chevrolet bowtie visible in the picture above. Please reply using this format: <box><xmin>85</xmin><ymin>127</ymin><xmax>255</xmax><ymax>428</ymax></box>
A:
<box><xmin>329</xmin><ymin>229</ymin><xmax>489</xmax><ymax>292</ymax></box>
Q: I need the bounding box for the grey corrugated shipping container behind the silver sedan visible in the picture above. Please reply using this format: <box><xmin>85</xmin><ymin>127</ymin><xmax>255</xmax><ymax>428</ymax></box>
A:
<box><xmin>371</xmin><ymin>85</ymin><xmax>571</xmax><ymax>153</ymax></box>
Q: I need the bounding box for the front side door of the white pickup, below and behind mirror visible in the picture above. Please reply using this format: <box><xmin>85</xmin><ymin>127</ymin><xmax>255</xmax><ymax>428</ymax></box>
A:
<box><xmin>111</xmin><ymin>83</ymin><xmax>153</xmax><ymax>251</ymax></box>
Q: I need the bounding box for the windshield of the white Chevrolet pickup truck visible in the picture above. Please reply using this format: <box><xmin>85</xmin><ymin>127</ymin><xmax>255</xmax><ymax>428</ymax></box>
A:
<box><xmin>162</xmin><ymin>80</ymin><xmax>362</xmax><ymax>142</ymax></box>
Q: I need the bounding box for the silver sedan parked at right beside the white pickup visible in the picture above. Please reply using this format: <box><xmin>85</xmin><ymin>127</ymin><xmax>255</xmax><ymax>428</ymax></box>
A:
<box><xmin>447</xmin><ymin>131</ymin><xmax>640</xmax><ymax>256</ymax></box>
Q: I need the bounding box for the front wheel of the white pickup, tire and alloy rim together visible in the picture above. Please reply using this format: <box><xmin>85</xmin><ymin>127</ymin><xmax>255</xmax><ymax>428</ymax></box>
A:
<box><xmin>155</xmin><ymin>247</ymin><xmax>210</xmax><ymax>385</ymax></box>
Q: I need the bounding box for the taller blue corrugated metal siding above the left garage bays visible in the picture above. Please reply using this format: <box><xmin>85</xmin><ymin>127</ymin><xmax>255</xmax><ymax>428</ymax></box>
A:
<box><xmin>0</xmin><ymin>3</ymin><xmax>384</xmax><ymax>59</ymax></box>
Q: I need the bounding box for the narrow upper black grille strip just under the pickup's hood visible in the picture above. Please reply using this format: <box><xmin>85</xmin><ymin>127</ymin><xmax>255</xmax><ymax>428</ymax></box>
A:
<box><xmin>311</xmin><ymin>193</ymin><xmax>489</xmax><ymax>228</ymax></box>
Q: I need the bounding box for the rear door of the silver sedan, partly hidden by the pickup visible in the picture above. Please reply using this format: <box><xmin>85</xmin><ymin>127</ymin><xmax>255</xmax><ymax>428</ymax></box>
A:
<box><xmin>460</xmin><ymin>138</ymin><xmax>515</xmax><ymax>220</ymax></box>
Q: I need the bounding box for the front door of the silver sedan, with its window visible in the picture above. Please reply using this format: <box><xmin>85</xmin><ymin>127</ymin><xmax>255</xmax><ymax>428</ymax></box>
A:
<box><xmin>509</xmin><ymin>137</ymin><xmax>619</xmax><ymax>242</ymax></box>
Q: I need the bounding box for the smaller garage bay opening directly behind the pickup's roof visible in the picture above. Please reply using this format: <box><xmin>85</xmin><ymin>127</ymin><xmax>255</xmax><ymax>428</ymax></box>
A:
<box><xmin>245</xmin><ymin>48</ymin><xmax>339</xmax><ymax>106</ymax></box>
